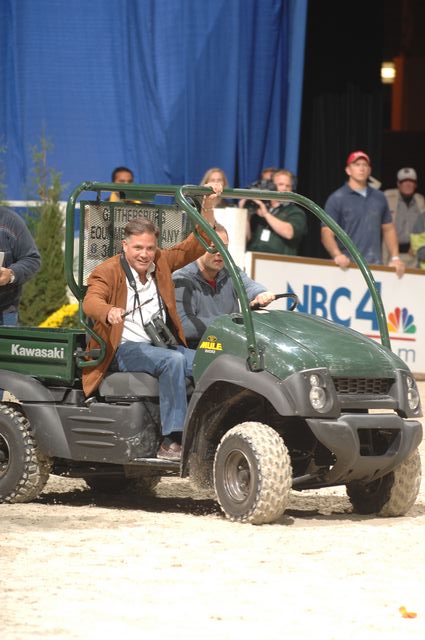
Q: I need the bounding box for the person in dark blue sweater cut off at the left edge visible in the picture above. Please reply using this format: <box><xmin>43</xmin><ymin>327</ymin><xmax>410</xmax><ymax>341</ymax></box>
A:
<box><xmin>0</xmin><ymin>206</ymin><xmax>41</xmax><ymax>326</ymax></box>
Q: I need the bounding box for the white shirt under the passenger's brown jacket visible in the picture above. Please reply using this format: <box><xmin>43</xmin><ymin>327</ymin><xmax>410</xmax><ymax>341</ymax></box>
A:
<box><xmin>121</xmin><ymin>264</ymin><xmax>165</xmax><ymax>344</ymax></box>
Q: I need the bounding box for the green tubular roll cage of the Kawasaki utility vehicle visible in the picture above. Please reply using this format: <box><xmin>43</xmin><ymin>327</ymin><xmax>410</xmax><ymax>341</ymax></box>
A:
<box><xmin>65</xmin><ymin>182</ymin><xmax>391</xmax><ymax>371</ymax></box>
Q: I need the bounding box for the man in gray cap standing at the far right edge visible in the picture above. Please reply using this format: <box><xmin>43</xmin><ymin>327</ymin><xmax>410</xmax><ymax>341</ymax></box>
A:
<box><xmin>383</xmin><ymin>167</ymin><xmax>425</xmax><ymax>267</ymax></box>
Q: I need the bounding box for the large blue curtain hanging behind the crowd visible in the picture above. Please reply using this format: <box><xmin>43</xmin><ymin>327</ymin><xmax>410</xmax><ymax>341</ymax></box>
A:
<box><xmin>0</xmin><ymin>0</ymin><xmax>307</xmax><ymax>199</ymax></box>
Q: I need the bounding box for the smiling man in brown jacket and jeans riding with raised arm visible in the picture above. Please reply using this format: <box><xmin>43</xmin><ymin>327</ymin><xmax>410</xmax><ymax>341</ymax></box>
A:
<box><xmin>83</xmin><ymin>184</ymin><xmax>222</xmax><ymax>460</ymax></box>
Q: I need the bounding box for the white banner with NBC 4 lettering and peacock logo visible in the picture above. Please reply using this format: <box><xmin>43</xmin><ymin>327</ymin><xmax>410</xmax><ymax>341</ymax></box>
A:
<box><xmin>246</xmin><ymin>253</ymin><xmax>425</xmax><ymax>375</ymax></box>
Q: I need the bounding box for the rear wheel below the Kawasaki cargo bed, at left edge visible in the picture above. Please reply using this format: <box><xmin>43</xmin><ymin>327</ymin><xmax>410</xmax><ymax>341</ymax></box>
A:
<box><xmin>0</xmin><ymin>404</ymin><xmax>51</xmax><ymax>503</ymax></box>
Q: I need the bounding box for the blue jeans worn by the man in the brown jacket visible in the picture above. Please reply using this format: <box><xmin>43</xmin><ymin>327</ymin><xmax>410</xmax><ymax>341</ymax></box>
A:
<box><xmin>115</xmin><ymin>342</ymin><xmax>196</xmax><ymax>436</ymax></box>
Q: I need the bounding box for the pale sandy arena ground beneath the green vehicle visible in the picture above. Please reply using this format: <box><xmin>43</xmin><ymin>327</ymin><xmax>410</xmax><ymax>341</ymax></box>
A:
<box><xmin>0</xmin><ymin>382</ymin><xmax>425</xmax><ymax>640</ymax></box>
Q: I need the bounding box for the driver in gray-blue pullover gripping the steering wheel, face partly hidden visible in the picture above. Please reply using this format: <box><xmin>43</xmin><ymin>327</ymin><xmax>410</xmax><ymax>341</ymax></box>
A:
<box><xmin>173</xmin><ymin>224</ymin><xmax>275</xmax><ymax>349</ymax></box>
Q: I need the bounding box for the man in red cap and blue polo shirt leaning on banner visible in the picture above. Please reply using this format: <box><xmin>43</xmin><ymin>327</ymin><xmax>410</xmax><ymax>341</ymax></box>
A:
<box><xmin>322</xmin><ymin>151</ymin><xmax>405</xmax><ymax>277</ymax></box>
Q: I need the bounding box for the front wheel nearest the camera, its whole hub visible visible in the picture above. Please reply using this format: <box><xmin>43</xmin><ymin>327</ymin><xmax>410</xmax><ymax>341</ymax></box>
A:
<box><xmin>214</xmin><ymin>422</ymin><xmax>292</xmax><ymax>524</ymax></box>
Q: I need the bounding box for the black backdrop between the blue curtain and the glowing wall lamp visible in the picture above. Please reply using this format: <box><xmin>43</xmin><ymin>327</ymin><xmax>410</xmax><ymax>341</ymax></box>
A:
<box><xmin>298</xmin><ymin>0</ymin><xmax>384</xmax><ymax>257</ymax></box>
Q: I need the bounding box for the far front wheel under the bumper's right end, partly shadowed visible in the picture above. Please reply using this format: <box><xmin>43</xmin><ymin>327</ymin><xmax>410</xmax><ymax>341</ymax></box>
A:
<box><xmin>346</xmin><ymin>449</ymin><xmax>421</xmax><ymax>517</ymax></box>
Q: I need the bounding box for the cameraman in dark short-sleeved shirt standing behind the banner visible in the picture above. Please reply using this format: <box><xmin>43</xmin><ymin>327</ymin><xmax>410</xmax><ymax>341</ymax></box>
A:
<box><xmin>247</xmin><ymin>169</ymin><xmax>307</xmax><ymax>256</ymax></box>
